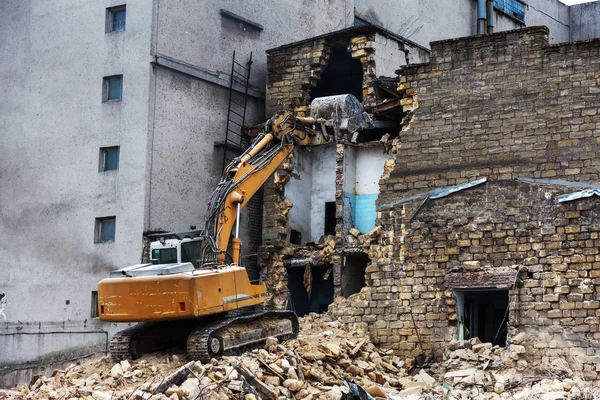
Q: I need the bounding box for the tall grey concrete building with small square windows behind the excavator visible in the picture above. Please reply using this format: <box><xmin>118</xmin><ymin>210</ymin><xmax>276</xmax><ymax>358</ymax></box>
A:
<box><xmin>0</xmin><ymin>0</ymin><xmax>599</xmax><ymax>383</ymax></box>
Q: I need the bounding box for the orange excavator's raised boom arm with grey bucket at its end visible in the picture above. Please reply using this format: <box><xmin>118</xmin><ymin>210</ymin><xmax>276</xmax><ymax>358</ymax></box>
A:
<box><xmin>204</xmin><ymin>95</ymin><xmax>372</xmax><ymax>265</ymax></box>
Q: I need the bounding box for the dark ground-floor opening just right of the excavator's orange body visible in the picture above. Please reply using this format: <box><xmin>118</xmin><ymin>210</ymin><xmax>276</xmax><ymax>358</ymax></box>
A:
<box><xmin>287</xmin><ymin>265</ymin><xmax>333</xmax><ymax>317</ymax></box>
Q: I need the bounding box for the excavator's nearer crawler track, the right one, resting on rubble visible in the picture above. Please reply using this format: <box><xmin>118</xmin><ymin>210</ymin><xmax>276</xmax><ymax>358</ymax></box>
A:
<box><xmin>187</xmin><ymin>311</ymin><xmax>299</xmax><ymax>363</ymax></box>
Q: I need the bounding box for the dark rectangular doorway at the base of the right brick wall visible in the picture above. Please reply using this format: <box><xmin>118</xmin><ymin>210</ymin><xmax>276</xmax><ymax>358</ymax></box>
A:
<box><xmin>457</xmin><ymin>290</ymin><xmax>508</xmax><ymax>347</ymax></box>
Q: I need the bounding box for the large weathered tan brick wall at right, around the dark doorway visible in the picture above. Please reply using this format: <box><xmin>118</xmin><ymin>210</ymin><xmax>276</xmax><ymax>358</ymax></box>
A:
<box><xmin>332</xmin><ymin>27</ymin><xmax>600</xmax><ymax>379</ymax></box>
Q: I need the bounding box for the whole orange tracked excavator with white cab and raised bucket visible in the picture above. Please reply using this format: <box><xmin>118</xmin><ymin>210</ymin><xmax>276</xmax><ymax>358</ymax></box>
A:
<box><xmin>98</xmin><ymin>95</ymin><xmax>371</xmax><ymax>362</ymax></box>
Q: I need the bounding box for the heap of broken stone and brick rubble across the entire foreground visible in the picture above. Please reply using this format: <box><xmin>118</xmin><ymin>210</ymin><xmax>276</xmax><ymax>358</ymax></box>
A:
<box><xmin>0</xmin><ymin>315</ymin><xmax>600</xmax><ymax>400</ymax></box>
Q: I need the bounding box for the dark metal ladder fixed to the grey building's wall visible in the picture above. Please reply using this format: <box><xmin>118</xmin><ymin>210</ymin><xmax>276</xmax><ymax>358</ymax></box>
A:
<box><xmin>215</xmin><ymin>51</ymin><xmax>252</xmax><ymax>169</ymax></box>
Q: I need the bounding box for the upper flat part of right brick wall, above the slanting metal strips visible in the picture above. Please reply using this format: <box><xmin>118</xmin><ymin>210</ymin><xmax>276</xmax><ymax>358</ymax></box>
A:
<box><xmin>380</xmin><ymin>27</ymin><xmax>600</xmax><ymax>204</ymax></box>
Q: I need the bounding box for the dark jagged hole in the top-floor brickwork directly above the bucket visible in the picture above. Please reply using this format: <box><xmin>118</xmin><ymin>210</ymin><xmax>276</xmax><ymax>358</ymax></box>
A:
<box><xmin>310</xmin><ymin>41</ymin><xmax>363</xmax><ymax>101</ymax></box>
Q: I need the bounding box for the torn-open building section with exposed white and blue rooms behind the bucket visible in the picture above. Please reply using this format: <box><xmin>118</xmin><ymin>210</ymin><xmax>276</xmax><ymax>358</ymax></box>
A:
<box><xmin>259</xmin><ymin>26</ymin><xmax>429</xmax><ymax>314</ymax></box>
